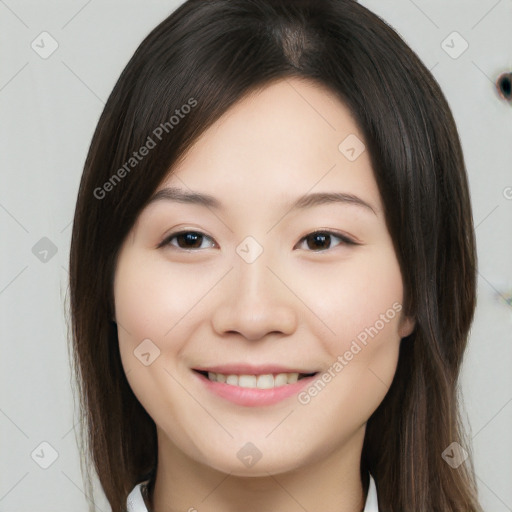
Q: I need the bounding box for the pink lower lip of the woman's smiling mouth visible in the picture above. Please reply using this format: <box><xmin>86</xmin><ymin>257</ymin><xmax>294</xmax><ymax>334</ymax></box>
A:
<box><xmin>194</xmin><ymin>371</ymin><xmax>317</xmax><ymax>407</ymax></box>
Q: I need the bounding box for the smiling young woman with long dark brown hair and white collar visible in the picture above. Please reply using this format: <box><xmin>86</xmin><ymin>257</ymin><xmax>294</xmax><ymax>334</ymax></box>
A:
<box><xmin>70</xmin><ymin>0</ymin><xmax>481</xmax><ymax>512</ymax></box>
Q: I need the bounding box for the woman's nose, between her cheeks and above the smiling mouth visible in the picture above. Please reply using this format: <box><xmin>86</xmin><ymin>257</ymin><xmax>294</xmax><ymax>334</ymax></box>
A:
<box><xmin>212</xmin><ymin>247</ymin><xmax>299</xmax><ymax>341</ymax></box>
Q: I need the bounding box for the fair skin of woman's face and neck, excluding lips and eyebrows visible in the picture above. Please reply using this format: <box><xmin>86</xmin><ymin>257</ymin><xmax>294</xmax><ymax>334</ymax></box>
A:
<box><xmin>114</xmin><ymin>78</ymin><xmax>414</xmax><ymax>512</ymax></box>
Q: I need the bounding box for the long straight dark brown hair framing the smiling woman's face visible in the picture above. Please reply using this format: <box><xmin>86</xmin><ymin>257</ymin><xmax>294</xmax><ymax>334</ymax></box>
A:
<box><xmin>70</xmin><ymin>0</ymin><xmax>482</xmax><ymax>512</ymax></box>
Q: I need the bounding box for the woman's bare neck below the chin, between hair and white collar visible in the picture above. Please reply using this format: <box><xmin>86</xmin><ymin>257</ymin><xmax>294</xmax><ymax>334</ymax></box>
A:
<box><xmin>148</xmin><ymin>428</ymin><xmax>367</xmax><ymax>512</ymax></box>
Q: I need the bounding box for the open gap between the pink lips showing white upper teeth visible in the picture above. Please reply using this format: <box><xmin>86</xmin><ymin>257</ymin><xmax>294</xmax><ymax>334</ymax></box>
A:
<box><xmin>194</xmin><ymin>370</ymin><xmax>319</xmax><ymax>389</ymax></box>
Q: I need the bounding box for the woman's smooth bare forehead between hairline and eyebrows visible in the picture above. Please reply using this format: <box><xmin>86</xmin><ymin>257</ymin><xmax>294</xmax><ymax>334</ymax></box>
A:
<box><xmin>150</xmin><ymin>78</ymin><xmax>380</xmax><ymax>216</ymax></box>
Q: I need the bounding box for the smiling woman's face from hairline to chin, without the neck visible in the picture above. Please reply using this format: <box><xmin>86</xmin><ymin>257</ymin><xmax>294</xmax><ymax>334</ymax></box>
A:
<box><xmin>114</xmin><ymin>79</ymin><xmax>413</xmax><ymax>475</ymax></box>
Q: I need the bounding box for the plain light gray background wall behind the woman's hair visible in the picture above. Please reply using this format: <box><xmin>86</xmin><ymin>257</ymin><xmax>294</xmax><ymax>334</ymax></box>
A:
<box><xmin>0</xmin><ymin>0</ymin><xmax>512</xmax><ymax>512</ymax></box>
